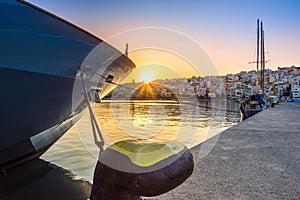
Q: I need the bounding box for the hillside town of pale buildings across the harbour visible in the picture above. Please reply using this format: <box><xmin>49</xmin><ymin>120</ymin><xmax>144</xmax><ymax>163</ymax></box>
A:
<box><xmin>110</xmin><ymin>66</ymin><xmax>300</xmax><ymax>101</ymax></box>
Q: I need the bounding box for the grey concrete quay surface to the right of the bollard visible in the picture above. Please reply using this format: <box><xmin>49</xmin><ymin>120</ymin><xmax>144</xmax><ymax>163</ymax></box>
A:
<box><xmin>157</xmin><ymin>103</ymin><xmax>300</xmax><ymax>200</ymax></box>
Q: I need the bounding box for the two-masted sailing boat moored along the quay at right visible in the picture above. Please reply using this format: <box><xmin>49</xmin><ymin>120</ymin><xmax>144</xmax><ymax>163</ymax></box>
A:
<box><xmin>240</xmin><ymin>19</ymin><xmax>266</xmax><ymax>119</ymax></box>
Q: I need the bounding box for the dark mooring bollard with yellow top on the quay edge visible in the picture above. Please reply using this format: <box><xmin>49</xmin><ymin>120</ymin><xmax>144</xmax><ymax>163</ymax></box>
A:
<box><xmin>91</xmin><ymin>140</ymin><xmax>194</xmax><ymax>200</ymax></box>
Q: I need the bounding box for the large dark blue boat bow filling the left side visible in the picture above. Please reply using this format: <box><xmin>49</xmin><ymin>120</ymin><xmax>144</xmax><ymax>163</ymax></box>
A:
<box><xmin>0</xmin><ymin>0</ymin><xmax>135</xmax><ymax>171</ymax></box>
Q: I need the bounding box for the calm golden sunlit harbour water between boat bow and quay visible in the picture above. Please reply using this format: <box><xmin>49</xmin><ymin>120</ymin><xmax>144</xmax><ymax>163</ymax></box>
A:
<box><xmin>42</xmin><ymin>100</ymin><xmax>240</xmax><ymax>183</ymax></box>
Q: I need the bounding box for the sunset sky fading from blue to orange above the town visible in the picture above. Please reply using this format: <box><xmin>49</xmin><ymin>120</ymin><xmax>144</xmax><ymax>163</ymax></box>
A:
<box><xmin>29</xmin><ymin>0</ymin><xmax>300</xmax><ymax>81</ymax></box>
